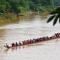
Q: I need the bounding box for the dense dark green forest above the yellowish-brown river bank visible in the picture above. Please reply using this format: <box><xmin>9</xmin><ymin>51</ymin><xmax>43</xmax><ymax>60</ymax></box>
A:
<box><xmin>0</xmin><ymin>0</ymin><xmax>60</xmax><ymax>15</ymax></box>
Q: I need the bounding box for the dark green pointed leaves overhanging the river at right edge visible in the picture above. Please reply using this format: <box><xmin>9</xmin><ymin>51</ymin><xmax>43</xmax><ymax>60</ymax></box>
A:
<box><xmin>47</xmin><ymin>7</ymin><xmax>60</xmax><ymax>25</ymax></box>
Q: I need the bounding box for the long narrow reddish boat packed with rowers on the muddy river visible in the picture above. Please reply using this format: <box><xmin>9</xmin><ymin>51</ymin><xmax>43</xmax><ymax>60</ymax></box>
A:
<box><xmin>5</xmin><ymin>33</ymin><xmax>60</xmax><ymax>48</ymax></box>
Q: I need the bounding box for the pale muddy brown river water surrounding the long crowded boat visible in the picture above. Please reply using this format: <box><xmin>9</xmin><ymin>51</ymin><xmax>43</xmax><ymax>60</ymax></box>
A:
<box><xmin>0</xmin><ymin>16</ymin><xmax>60</xmax><ymax>60</ymax></box>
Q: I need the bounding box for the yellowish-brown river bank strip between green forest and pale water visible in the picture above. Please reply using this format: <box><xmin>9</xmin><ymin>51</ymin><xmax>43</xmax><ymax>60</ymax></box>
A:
<box><xmin>0</xmin><ymin>12</ymin><xmax>48</xmax><ymax>26</ymax></box>
